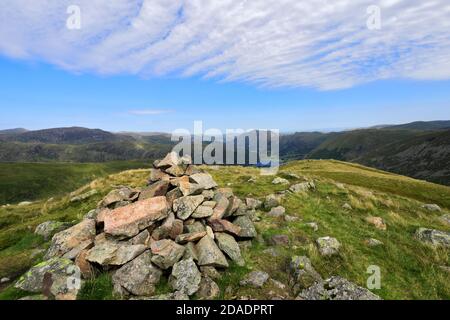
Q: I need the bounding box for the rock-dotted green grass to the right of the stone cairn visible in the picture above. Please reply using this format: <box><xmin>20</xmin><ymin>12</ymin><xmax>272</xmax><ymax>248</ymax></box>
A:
<box><xmin>203</xmin><ymin>161</ymin><xmax>450</xmax><ymax>299</ymax></box>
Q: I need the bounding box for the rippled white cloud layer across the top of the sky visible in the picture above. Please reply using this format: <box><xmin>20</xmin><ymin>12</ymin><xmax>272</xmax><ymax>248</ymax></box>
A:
<box><xmin>0</xmin><ymin>0</ymin><xmax>450</xmax><ymax>90</ymax></box>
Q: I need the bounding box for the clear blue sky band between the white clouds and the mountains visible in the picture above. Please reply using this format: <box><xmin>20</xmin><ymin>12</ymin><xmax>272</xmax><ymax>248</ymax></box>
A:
<box><xmin>0</xmin><ymin>58</ymin><xmax>450</xmax><ymax>132</ymax></box>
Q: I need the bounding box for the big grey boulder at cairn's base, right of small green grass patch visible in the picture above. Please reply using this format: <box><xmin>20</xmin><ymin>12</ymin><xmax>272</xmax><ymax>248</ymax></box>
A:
<box><xmin>113</xmin><ymin>251</ymin><xmax>162</xmax><ymax>296</ymax></box>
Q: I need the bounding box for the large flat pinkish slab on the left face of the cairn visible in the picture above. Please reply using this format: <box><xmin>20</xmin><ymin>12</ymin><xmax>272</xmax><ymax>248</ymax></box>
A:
<box><xmin>105</xmin><ymin>197</ymin><xmax>168</xmax><ymax>237</ymax></box>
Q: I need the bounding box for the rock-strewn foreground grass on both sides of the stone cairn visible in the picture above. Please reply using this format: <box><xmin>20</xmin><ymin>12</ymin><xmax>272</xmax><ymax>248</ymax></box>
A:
<box><xmin>0</xmin><ymin>160</ymin><xmax>450</xmax><ymax>299</ymax></box>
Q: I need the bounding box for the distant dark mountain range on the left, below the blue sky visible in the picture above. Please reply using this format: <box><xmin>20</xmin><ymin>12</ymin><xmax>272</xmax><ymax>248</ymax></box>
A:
<box><xmin>0</xmin><ymin>127</ymin><xmax>172</xmax><ymax>162</ymax></box>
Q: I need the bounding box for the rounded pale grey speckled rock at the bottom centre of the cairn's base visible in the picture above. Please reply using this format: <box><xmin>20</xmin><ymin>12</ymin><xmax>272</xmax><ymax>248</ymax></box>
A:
<box><xmin>169</xmin><ymin>258</ymin><xmax>202</xmax><ymax>296</ymax></box>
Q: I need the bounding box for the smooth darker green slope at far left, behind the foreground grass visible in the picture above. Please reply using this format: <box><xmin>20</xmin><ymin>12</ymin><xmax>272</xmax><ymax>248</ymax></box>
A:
<box><xmin>0</xmin><ymin>161</ymin><xmax>151</xmax><ymax>205</ymax></box>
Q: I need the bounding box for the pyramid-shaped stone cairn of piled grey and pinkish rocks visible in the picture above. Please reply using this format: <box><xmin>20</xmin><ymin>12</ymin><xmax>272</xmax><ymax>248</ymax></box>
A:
<box><xmin>16</xmin><ymin>152</ymin><xmax>258</xmax><ymax>300</ymax></box>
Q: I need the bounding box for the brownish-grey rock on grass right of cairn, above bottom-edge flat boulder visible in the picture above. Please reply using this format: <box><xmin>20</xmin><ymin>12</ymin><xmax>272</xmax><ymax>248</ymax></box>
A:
<box><xmin>289</xmin><ymin>256</ymin><xmax>323</xmax><ymax>294</ymax></box>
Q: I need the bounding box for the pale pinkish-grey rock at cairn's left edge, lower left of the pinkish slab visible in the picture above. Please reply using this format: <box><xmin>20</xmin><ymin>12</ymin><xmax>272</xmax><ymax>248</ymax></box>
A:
<box><xmin>45</xmin><ymin>219</ymin><xmax>96</xmax><ymax>259</ymax></box>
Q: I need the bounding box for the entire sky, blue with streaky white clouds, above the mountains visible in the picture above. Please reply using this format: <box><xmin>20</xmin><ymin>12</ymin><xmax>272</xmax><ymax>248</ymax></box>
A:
<box><xmin>0</xmin><ymin>0</ymin><xmax>450</xmax><ymax>132</ymax></box>
